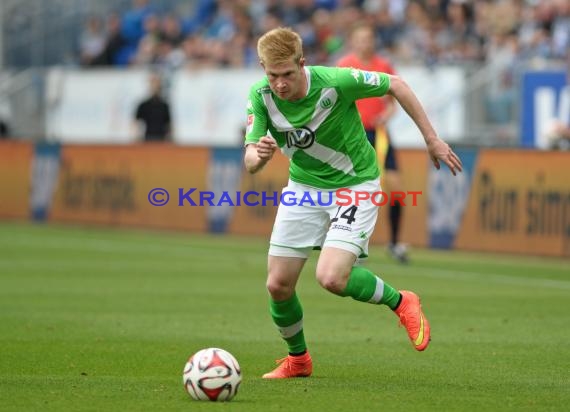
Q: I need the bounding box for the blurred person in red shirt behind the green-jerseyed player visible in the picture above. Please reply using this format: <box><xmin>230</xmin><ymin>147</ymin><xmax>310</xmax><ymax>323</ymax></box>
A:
<box><xmin>337</xmin><ymin>24</ymin><xmax>408</xmax><ymax>263</ymax></box>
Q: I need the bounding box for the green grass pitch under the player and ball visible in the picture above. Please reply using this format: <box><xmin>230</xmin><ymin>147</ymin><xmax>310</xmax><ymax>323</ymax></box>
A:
<box><xmin>0</xmin><ymin>223</ymin><xmax>570</xmax><ymax>412</ymax></box>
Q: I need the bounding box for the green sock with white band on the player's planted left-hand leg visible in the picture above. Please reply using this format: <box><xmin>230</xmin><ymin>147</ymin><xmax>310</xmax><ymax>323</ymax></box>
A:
<box><xmin>269</xmin><ymin>293</ymin><xmax>307</xmax><ymax>353</ymax></box>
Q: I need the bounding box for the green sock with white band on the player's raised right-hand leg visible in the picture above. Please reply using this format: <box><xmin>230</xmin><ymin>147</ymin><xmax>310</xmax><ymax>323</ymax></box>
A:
<box><xmin>342</xmin><ymin>266</ymin><xmax>400</xmax><ymax>310</ymax></box>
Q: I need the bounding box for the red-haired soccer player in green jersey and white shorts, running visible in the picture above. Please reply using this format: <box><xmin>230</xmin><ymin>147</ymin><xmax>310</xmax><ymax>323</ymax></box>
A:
<box><xmin>244</xmin><ymin>28</ymin><xmax>462</xmax><ymax>379</ymax></box>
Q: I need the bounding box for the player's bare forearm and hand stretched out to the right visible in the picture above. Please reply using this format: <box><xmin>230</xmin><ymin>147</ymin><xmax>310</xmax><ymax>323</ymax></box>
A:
<box><xmin>388</xmin><ymin>75</ymin><xmax>463</xmax><ymax>175</ymax></box>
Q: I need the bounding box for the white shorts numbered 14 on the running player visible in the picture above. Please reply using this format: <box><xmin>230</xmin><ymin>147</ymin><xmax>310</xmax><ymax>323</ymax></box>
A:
<box><xmin>269</xmin><ymin>180</ymin><xmax>381</xmax><ymax>258</ymax></box>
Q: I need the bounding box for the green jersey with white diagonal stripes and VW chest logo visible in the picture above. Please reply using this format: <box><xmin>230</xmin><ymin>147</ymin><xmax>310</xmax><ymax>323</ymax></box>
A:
<box><xmin>245</xmin><ymin>66</ymin><xmax>390</xmax><ymax>189</ymax></box>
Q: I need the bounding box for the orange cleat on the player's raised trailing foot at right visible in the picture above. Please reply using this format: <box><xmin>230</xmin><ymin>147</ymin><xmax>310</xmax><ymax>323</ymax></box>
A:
<box><xmin>394</xmin><ymin>290</ymin><xmax>431</xmax><ymax>351</ymax></box>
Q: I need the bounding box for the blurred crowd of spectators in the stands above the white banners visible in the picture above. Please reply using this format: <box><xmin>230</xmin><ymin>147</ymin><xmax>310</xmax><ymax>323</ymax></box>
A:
<box><xmin>79</xmin><ymin>0</ymin><xmax>570</xmax><ymax>71</ymax></box>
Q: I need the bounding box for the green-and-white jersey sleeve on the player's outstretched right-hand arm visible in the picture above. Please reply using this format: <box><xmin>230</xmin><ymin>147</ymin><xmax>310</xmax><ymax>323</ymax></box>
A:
<box><xmin>337</xmin><ymin>68</ymin><xmax>390</xmax><ymax>100</ymax></box>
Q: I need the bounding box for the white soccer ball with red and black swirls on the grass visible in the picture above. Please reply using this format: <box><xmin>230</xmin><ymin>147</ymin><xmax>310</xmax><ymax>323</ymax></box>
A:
<box><xmin>182</xmin><ymin>348</ymin><xmax>241</xmax><ymax>401</ymax></box>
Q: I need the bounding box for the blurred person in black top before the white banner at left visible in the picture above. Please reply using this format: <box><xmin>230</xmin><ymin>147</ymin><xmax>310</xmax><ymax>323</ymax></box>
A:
<box><xmin>135</xmin><ymin>73</ymin><xmax>171</xmax><ymax>142</ymax></box>
